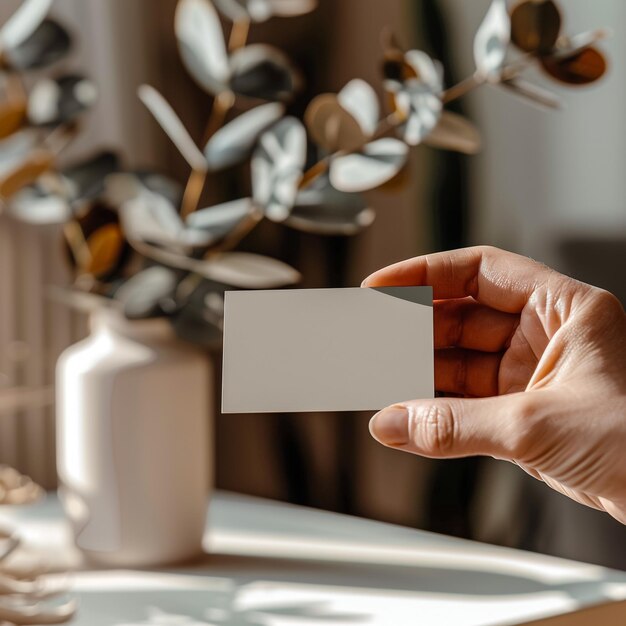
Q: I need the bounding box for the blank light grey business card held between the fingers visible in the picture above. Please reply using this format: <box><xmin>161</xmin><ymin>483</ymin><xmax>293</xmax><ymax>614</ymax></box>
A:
<box><xmin>222</xmin><ymin>287</ymin><xmax>434</xmax><ymax>413</ymax></box>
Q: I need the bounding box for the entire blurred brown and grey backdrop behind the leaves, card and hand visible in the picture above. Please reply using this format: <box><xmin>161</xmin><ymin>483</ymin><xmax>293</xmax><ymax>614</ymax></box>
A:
<box><xmin>0</xmin><ymin>0</ymin><xmax>626</xmax><ymax>569</ymax></box>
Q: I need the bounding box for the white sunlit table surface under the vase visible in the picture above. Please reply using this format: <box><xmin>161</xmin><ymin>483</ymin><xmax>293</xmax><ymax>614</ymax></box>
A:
<box><xmin>0</xmin><ymin>493</ymin><xmax>626</xmax><ymax>626</ymax></box>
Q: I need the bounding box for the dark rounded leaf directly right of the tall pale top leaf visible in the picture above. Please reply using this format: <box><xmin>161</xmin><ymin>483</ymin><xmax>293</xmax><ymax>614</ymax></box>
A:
<box><xmin>230</xmin><ymin>44</ymin><xmax>302</xmax><ymax>101</ymax></box>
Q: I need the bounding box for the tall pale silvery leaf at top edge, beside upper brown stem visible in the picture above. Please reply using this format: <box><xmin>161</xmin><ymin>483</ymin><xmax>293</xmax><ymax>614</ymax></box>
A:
<box><xmin>174</xmin><ymin>0</ymin><xmax>230</xmax><ymax>95</ymax></box>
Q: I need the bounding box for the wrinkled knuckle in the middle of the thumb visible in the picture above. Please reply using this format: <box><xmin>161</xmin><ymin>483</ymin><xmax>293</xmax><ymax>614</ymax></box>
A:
<box><xmin>409</xmin><ymin>403</ymin><xmax>456</xmax><ymax>456</ymax></box>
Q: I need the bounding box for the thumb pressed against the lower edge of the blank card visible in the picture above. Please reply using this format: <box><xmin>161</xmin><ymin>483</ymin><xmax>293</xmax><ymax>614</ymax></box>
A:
<box><xmin>370</xmin><ymin>392</ymin><xmax>545</xmax><ymax>460</ymax></box>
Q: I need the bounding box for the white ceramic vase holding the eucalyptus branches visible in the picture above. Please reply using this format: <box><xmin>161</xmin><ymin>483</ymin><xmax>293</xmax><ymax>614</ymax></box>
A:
<box><xmin>56</xmin><ymin>310</ymin><xmax>213</xmax><ymax>567</ymax></box>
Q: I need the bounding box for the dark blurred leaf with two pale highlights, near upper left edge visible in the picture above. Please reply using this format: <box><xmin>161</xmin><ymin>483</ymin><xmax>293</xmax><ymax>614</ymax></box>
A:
<box><xmin>28</xmin><ymin>74</ymin><xmax>98</xmax><ymax>126</ymax></box>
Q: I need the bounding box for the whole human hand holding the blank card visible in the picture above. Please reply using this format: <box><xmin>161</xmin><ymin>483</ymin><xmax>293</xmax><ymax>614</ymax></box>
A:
<box><xmin>363</xmin><ymin>247</ymin><xmax>626</xmax><ymax>524</ymax></box>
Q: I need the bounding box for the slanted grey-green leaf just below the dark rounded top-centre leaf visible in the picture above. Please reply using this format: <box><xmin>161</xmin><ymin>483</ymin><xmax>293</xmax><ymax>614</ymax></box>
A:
<box><xmin>204</xmin><ymin>102</ymin><xmax>285</xmax><ymax>171</ymax></box>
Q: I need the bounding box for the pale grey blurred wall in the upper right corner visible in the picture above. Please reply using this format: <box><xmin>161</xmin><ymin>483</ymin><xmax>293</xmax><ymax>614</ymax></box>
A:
<box><xmin>444</xmin><ymin>0</ymin><xmax>626</xmax><ymax>265</ymax></box>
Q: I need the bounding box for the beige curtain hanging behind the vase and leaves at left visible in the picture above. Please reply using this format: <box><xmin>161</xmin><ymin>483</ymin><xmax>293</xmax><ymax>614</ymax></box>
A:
<box><xmin>0</xmin><ymin>0</ymin><xmax>164</xmax><ymax>486</ymax></box>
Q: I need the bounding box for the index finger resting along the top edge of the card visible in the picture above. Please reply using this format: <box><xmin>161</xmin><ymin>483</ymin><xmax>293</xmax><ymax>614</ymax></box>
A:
<box><xmin>362</xmin><ymin>246</ymin><xmax>553</xmax><ymax>313</ymax></box>
